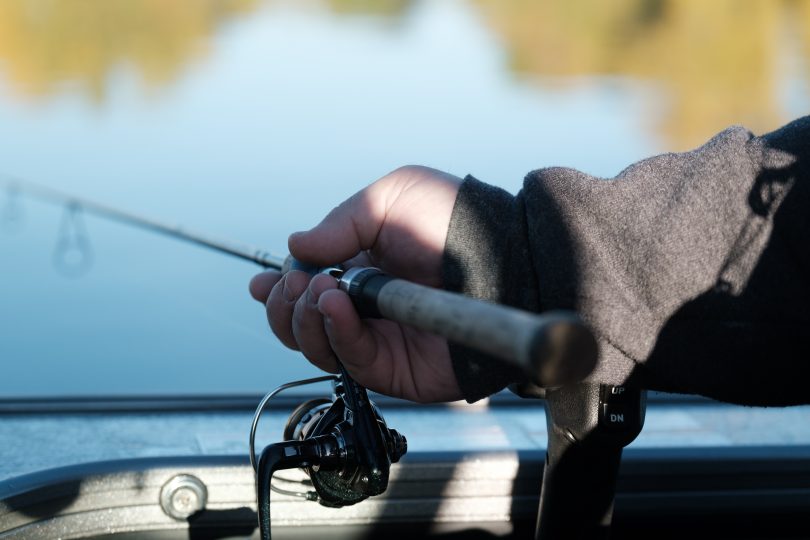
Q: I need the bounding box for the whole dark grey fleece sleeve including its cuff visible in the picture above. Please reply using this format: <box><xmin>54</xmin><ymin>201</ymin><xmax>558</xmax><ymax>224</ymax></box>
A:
<box><xmin>444</xmin><ymin>117</ymin><xmax>810</xmax><ymax>405</ymax></box>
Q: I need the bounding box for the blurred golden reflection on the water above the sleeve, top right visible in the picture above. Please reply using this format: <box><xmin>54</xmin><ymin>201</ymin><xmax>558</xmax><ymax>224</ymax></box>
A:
<box><xmin>475</xmin><ymin>0</ymin><xmax>810</xmax><ymax>148</ymax></box>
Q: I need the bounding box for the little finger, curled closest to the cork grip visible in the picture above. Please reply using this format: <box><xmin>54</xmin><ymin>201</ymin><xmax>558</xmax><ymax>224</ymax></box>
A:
<box><xmin>318</xmin><ymin>290</ymin><xmax>381</xmax><ymax>382</ymax></box>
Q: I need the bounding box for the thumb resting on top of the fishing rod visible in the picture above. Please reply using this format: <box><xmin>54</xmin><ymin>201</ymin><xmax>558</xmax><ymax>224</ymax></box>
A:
<box><xmin>288</xmin><ymin>177</ymin><xmax>396</xmax><ymax>265</ymax></box>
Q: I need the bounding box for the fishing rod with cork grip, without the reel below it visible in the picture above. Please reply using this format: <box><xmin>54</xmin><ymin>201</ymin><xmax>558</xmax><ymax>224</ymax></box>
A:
<box><xmin>5</xmin><ymin>173</ymin><xmax>597</xmax><ymax>387</ymax></box>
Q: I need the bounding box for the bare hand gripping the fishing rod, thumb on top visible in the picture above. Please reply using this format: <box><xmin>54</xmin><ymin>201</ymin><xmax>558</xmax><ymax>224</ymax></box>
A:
<box><xmin>250</xmin><ymin>166</ymin><xmax>462</xmax><ymax>402</ymax></box>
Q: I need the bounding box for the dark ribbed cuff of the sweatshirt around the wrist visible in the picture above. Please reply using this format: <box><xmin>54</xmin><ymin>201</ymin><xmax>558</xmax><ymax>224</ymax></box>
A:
<box><xmin>442</xmin><ymin>176</ymin><xmax>539</xmax><ymax>403</ymax></box>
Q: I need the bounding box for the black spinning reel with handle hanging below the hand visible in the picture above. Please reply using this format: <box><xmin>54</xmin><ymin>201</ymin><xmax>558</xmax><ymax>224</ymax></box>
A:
<box><xmin>250</xmin><ymin>365</ymin><xmax>408</xmax><ymax>540</ymax></box>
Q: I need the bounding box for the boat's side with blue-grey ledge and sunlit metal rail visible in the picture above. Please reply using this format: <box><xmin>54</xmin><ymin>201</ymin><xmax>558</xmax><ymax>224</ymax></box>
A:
<box><xmin>0</xmin><ymin>394</ymin><xmax>810</xmax><ymax>540</ymax></box>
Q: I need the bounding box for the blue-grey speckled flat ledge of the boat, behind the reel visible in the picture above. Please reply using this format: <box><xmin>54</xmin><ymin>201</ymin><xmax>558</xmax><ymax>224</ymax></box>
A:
<box><xmin>0</xmin><ymin>398</ymin><xmax>810</xmax><ymax>481</ymax></box>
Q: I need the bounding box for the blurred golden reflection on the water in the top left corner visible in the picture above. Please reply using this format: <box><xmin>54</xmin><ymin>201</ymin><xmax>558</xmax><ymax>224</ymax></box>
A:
<box><xmin>0</xmin><ymin>0</ymin><xmax>256</xmax><ymax>100</ymax></box>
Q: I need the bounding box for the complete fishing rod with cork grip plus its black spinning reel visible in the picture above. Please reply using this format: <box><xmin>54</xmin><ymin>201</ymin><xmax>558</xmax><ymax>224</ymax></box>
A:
<box><xmin>6</xmin><ymin>175</ymin><xmax>598</xmax><ymax>540</ymax></box>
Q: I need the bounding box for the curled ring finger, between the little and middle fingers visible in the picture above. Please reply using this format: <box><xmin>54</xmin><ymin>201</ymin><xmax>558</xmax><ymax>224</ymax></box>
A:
<box><xmin>292</xmin><ymin>274</ymin><xmax>338</xmax><ymax>373</ymax></box>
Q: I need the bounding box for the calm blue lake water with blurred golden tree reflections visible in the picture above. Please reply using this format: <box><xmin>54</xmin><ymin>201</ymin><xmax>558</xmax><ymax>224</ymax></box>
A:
<box><xmin>0</xmin><ymin>0</ymin><xmax>810</xmax><ymax>396</ymax></box>
